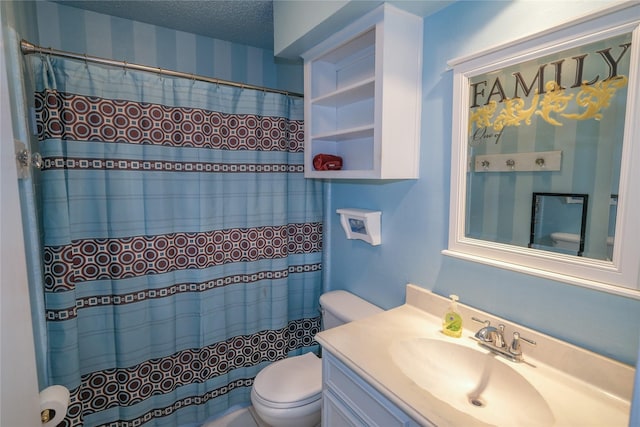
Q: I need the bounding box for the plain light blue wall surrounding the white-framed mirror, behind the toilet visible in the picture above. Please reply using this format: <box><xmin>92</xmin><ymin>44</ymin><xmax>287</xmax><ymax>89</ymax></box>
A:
<box><xmin>325</xmin><ymin>1</ymin><xmax>640</xmax><ymax>365</ymax></box>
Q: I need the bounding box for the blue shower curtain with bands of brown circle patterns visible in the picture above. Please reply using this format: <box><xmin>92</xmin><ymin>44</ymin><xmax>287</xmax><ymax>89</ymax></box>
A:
<box><xmin>30</xmin><ymin>56</ymin><xmax>322</xmax><ymax>426</ymax></box>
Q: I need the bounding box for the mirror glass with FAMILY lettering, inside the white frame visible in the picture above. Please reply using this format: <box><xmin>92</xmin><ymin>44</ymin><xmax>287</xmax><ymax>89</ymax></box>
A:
<box><xmin>465</xmin><ymin>33</ymin><xmax>631</xmax><ymax>260</ymax></box>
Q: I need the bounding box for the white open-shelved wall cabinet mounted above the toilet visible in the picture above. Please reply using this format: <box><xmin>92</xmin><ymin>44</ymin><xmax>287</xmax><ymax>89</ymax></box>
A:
<box><xmin>302</xmin><ymin>4</ymin><xmax>422</xmax><ymax>179</ymax></box>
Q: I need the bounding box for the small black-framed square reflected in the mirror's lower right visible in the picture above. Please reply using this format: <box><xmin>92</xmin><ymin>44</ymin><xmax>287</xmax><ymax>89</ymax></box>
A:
<box><xmin>529</xmin><ymin>193</ymin><xmax>589</xmax><ymax>256</ymax></box>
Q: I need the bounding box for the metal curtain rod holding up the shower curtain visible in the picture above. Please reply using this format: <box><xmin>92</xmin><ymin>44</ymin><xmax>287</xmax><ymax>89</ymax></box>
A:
<box><xmin>20</xmin><ymin>40</ymin><xmax>304</xmax><ymax>98</ymax></box>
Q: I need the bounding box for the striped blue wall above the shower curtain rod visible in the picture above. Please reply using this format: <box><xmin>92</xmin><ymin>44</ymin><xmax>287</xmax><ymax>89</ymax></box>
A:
<box><xmin>34</xmin><ymin>1</ymin><xmax>304</xmax><ymax>93</ymax></box>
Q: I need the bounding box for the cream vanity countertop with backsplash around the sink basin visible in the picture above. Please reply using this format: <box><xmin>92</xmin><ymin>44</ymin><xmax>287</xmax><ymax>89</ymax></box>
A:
<box><xmin>316</xmin><ymin>285</ymin><xmax>635</xmax><ymax>427</ymax></box>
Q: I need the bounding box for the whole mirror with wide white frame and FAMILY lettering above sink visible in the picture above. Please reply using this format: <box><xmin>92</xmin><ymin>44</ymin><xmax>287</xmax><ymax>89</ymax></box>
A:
<box><xmin>444</xmin><ymin>7</ymin><xmax>640</xmax><ymax>298</ymax></box>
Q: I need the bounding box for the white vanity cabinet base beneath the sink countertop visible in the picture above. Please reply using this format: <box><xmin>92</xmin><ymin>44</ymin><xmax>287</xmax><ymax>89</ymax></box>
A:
<box><xmin>322</xmin><ymin>351</ymin><xmax>418</xmax><ymax>427</ymax></box>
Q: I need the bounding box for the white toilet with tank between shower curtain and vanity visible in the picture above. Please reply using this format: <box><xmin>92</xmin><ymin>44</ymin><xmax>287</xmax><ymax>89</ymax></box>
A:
<box><xmin>251</xmin><ymin>291</ymin><xmax>382</xmax><ymax>427</ymax></box>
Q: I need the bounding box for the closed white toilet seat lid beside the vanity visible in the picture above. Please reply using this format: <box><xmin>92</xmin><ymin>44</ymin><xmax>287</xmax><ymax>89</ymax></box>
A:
<box><xmin>252</xmin><ymin>353</ymin><xmax>322</xmax><ymax>409</ymax></box>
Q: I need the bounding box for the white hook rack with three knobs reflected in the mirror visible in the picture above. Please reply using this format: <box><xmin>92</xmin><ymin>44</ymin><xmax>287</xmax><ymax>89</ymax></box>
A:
<box><xmin>474</xmin><ymin>151</ymin><xmax>562</xmax><ymax>172</ymax></box>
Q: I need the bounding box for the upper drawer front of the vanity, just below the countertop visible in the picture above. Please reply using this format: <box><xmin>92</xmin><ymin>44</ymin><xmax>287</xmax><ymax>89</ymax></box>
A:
<box><xmin>323</xmin><ymin>353</ymin><xmax>417</xmax><ymax>427</ymax></box>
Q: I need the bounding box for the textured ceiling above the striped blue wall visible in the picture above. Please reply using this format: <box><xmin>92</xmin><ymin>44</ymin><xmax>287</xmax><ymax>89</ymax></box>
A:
<box><xmin>54</xmin><ymin>0</ymin><xmax>273</xmax><ymax>50</ymax></box>
